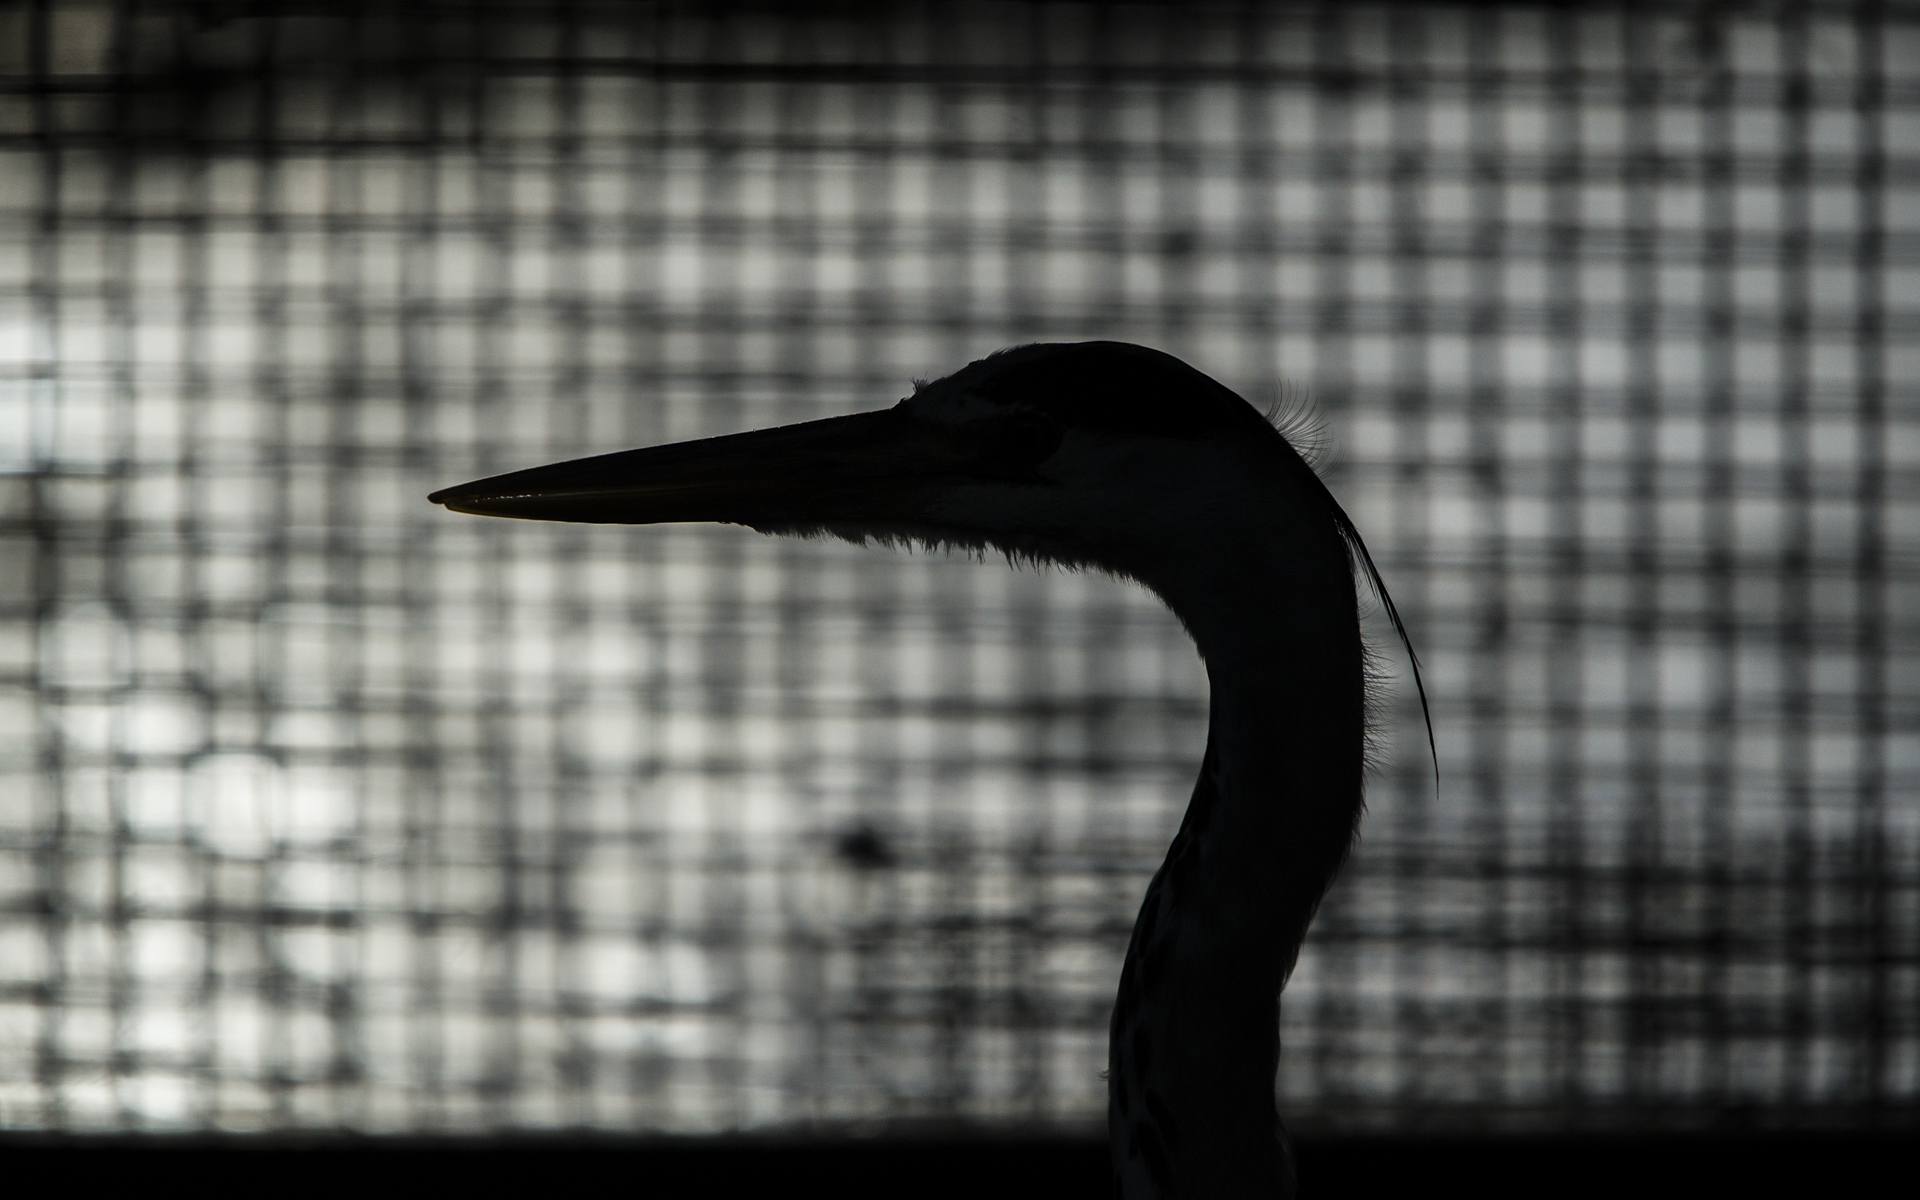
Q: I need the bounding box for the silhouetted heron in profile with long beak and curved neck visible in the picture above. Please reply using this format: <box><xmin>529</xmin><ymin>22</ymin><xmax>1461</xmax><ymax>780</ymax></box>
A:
<box><xmin>430</xmin><ymin>342</ymin><xmax>1432</xmax><ymax>1200</ymax></box>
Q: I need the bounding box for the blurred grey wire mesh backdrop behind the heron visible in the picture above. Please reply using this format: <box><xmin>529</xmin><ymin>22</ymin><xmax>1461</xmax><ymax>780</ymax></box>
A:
<box><xmin>0</xmin><ymin>4</ymin><xmax>1920</xmax><ymax>1131</ymax></box>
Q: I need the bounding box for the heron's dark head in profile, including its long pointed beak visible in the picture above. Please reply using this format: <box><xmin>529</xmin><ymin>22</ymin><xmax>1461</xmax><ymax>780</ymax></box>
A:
<box><xmin>430</xmin><ymin>342</ymin><xmax>1344</xmax><ymax>586</ymax></box>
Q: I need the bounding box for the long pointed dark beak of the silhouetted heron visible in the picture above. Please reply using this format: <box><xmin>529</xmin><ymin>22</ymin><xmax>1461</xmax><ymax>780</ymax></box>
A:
<box><xmin>426</xmin><ymin>409</ymin><xmax>975</xmax><ymax>526</ymax></box>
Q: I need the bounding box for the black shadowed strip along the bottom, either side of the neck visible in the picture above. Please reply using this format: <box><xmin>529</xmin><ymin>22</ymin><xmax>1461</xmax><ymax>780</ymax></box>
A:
<box><xmin>11</xmin><ymin>1133</ymin><xmax>1910</xmax><ymax>1200</ymax></box>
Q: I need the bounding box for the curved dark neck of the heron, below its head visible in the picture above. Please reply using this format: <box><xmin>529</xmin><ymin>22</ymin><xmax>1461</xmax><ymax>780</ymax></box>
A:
<box><xmin>1110</xmin><ymin>510</ymin><xmax>1365</xmax><ymax>1200</ymax></box>
